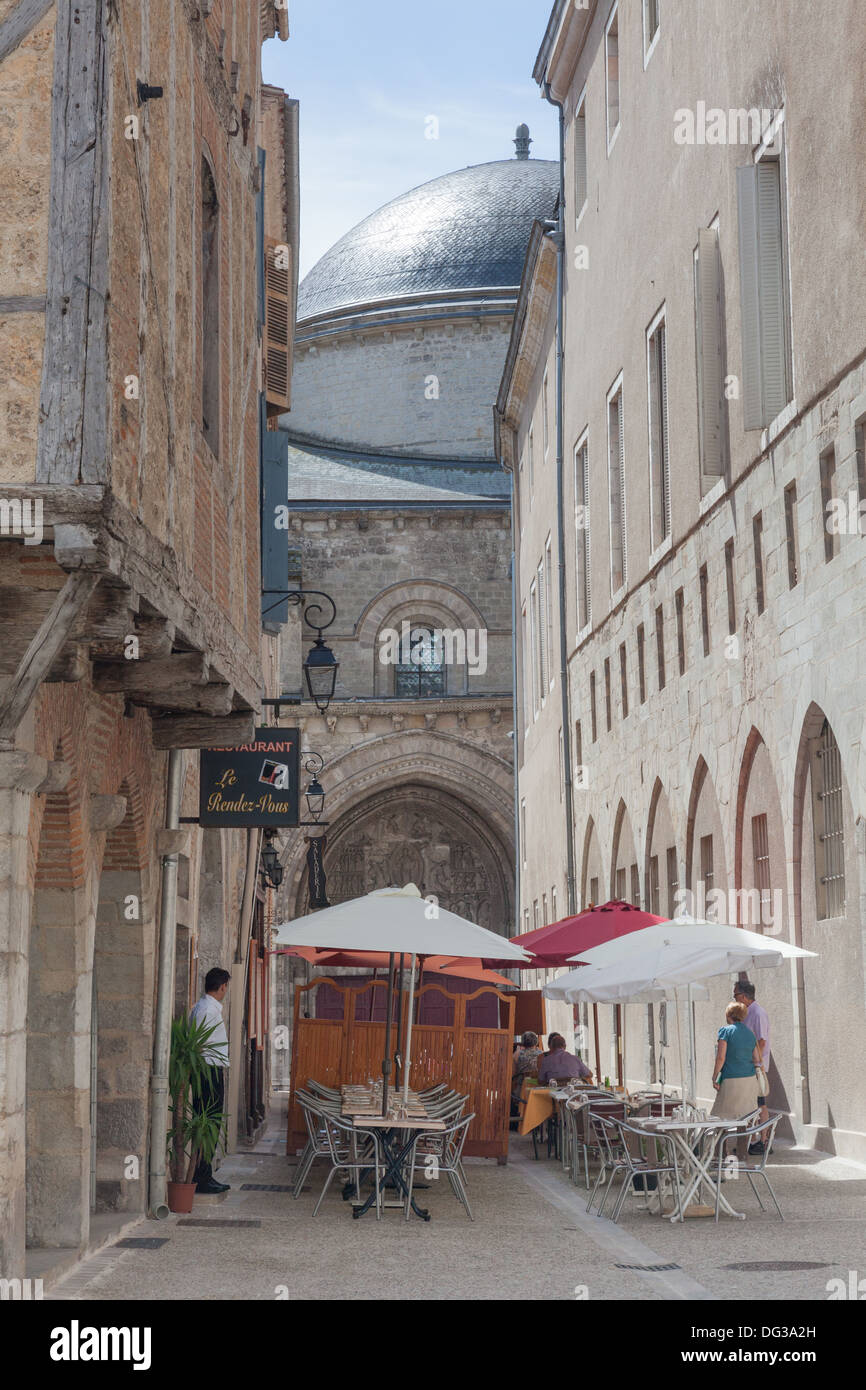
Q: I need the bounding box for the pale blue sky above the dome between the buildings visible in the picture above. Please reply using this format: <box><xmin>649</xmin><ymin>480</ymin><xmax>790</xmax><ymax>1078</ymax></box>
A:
<box><xmin>263</xmin><ymin>0</ymin><xmax>557</xmax><ymax>275</ymax></box>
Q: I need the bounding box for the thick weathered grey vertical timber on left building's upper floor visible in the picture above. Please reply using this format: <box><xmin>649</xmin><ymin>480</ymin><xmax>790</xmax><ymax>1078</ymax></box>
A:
<box><xmin>36</xmin><ymin>0</ymin><xmax>110</xmax><ymax>484</ymax></box>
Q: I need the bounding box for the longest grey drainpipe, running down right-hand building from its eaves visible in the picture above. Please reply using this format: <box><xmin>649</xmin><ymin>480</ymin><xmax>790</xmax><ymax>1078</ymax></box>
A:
<box><xmin>542</xmin><ymin>81</ymin><xmax>577</xmax><ymax>916</ymax></box>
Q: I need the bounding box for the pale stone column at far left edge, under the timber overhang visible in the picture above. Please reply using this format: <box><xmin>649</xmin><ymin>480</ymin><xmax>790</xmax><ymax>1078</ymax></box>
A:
<box><xmin>0</xmin><ymin>749</ymin><xmax>49</xmax><ymax>1279</ymax></box>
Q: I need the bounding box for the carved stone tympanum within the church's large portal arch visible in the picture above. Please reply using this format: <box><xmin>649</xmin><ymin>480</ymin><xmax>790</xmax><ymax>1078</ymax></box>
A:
<box><xmin>295</xmin><ymin>781</ymin><xmax>512</xmax><ymax>935</ymax></box>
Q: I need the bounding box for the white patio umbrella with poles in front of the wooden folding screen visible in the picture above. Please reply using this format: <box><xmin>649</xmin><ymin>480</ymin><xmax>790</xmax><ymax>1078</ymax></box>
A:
<box><xmin>275</xmin><ymin>883</ymin><xmax>530</xmax><ymax>1115</ymax></box>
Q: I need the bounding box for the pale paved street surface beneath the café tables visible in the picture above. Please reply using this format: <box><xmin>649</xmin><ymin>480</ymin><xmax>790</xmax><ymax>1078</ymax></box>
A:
<box><xmin>47</xmin><ymin>1099</ymin><xmax>866</xmax><ymax>1305</ymax></box>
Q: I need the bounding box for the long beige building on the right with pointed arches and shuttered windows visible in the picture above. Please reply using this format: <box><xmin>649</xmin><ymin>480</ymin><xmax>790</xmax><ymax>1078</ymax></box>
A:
<box><xmin>498</xmin><ymin>0</ymin><xmax>866</xmax><ymax>1159</ymax></box>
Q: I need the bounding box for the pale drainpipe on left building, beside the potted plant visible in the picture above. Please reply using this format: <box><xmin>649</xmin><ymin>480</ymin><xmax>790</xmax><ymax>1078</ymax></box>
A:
<box><xmin>149</xmin><ymin>748</ymin><xmax>183</xmax><ymax>1220</ymax></box>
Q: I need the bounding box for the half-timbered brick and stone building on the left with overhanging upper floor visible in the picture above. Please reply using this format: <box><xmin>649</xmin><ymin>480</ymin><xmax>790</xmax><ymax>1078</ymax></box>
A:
<box><xmin>0</xmin><ymin>0</ymin><xmax>296</xmax><ymax>1277</ymax></box>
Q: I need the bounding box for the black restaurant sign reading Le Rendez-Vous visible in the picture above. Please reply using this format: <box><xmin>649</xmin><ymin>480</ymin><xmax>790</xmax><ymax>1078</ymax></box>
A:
<box><xmin>199</xmin><ymin>728</ymin><xmax>300</xmax><ymax>827</ymax></box>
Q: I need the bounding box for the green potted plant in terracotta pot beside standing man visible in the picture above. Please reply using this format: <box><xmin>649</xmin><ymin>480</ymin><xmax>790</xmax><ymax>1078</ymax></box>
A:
<box><xmin>165</xmin><ymin>1015</ymin><xmax>225</xmax><ymax>1212</ymax></box>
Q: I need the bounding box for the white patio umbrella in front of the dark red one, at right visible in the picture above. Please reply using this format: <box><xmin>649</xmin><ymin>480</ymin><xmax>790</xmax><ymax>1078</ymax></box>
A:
<box><xmin>544</xmin><ymin>917</ymin><xmax>816</xmax><ymax>1101</ymax></box>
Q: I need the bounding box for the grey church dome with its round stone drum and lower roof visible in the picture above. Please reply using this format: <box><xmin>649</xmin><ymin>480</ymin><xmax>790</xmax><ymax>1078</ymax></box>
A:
<box><xmin>282</xmin><ymin>145</ymin><xmax>559</xmax><ymax>472</ymax></box>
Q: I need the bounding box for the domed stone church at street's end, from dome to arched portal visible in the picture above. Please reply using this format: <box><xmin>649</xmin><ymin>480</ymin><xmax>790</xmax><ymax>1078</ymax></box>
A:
<box><xmin>277</xmin><ymin>149</ymin><xmax>557</xmax><ymax>1073</ymax></box>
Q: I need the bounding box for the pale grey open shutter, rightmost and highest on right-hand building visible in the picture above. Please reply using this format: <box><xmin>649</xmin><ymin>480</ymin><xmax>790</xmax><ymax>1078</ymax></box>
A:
<box><xmin>737</xmin><ymin>160</ymin><xmax>788</xmax><ymax>430</ymax></box>
